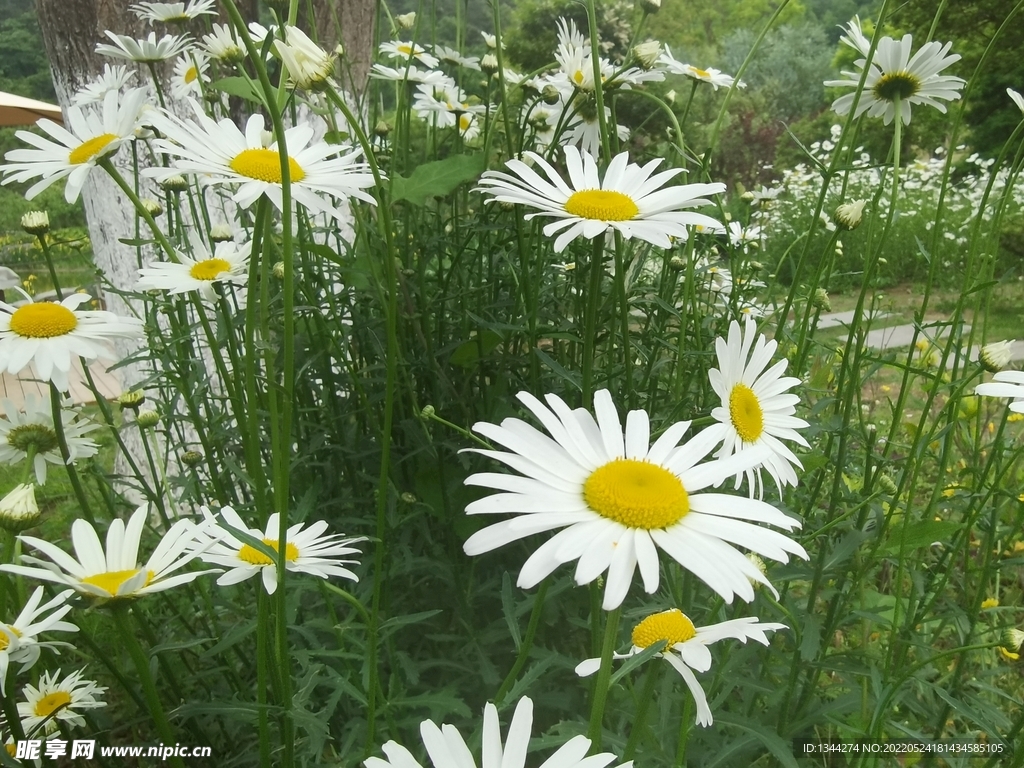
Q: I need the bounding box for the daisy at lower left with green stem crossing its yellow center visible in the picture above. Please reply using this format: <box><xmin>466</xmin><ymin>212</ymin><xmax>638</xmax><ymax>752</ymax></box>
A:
<box><xmin>193</xmin><ymin>507</ymin><xmax>366</xmax><ymax>595</ymax></box>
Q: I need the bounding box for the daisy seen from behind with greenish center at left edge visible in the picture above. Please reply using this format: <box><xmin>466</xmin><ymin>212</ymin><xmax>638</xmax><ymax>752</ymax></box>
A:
<box><xmin>0</xmin><ymin>392</ymin><xmax>99</xmax><ymax>485</ymax></box>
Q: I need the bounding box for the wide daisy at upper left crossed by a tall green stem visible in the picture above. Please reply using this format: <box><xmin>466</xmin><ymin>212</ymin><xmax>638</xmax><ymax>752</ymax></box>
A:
<box><xmin>143</xmin><ymin>101</ymin><xmax>375</xmax><ymax>217</ymax></box>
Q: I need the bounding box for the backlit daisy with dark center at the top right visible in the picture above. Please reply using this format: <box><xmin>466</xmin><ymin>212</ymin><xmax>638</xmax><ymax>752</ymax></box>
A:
<box><xmin>825</xmin><ymin>18</ymin><xmax>965</xmax><ymax>125</ymax></box>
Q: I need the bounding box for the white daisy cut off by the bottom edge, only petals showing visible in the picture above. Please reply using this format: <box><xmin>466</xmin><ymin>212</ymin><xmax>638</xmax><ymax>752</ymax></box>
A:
<box><xmin>362</xmin><ymin>696</ymin><xmax>633</xmax><ymax>768</ymax></box>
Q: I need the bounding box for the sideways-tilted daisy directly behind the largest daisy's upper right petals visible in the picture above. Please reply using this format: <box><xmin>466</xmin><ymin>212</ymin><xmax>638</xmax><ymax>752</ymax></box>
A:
<box><xmin>707</xmin><ymin>316</ymin><xmax>808</xmax><ymax>496</ymax></box>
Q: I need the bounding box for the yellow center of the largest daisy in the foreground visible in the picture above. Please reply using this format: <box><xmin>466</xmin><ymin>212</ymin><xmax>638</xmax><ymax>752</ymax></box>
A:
<box><xmin>583</xmin><ymin>459</ymin><xmax>690</xmax><ymax>530</ymax></box>
